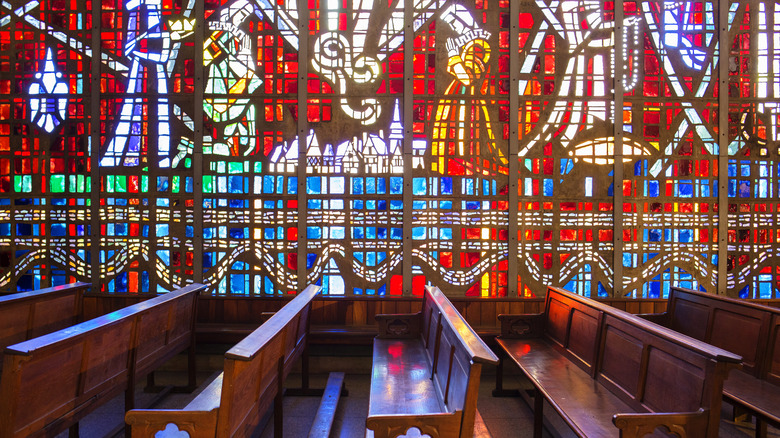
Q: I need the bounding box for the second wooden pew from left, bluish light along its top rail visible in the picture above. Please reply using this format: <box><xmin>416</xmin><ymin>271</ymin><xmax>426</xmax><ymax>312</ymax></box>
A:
<box><xmin>0</xmin><ymin>285</ymin><xmax>206</xmax><ymax>438</ymax></box>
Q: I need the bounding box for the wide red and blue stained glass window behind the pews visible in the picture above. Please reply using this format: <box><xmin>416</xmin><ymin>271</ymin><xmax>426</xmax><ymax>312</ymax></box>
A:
<box><xmin>0</xmin><ymin>0</ymin><xmax>780</xmax><ymax>298</ymax></box>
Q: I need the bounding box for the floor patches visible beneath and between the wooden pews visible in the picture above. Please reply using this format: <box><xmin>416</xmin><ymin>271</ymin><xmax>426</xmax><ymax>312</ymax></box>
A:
<box><xmin>57</xmin><ymin>348</ymin><xmax>780</xmax><ymax>438</ymax></box>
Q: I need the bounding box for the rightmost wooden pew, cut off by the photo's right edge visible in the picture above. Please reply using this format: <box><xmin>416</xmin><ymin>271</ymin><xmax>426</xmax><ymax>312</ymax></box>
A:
<box><xmin>639</xmin><ymin>287</ymin><xmax>780</xmax><ymax>436</ymax></box>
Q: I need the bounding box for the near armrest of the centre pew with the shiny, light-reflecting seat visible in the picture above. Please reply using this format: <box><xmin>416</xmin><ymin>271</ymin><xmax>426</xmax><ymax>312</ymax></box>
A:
<box><xmin>366</xmin><ymin>411</ymin><xmax>462</xmax><ymax>438</ymax></box>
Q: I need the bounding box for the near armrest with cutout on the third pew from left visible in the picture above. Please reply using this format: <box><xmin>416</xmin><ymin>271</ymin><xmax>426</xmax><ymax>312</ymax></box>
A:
<box><xmin>125</xmin><ymin>409</ymin><xmax>218</xmax><ymax>438</ymax></box>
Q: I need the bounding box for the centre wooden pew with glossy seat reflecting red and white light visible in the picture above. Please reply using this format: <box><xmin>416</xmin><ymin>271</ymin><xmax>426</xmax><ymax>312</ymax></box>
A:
<box><xmin>366</xmin><ymin>286</ymin><xmax>498</xmax><ymax>438</ymax></box>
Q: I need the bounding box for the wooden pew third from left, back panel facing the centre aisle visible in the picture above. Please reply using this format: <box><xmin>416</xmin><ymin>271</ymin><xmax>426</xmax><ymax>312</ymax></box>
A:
<box><xmin>125</xmin><ymin>285</ymin><xmax>343</xmax><ymax>438</ymax></box>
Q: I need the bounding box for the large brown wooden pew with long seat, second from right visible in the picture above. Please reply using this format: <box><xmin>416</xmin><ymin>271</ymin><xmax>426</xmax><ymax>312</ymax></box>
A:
<box><xmin>496</xmin><ymin>287</ymin><xmax>740</xmax><ymax>438</ymax></box>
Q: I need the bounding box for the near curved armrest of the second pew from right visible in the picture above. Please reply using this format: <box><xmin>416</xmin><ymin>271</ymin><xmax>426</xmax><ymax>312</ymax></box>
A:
<box><xmin>612</xmin><ymin>408</ymin><xmax>708</xmax><ymax>438</ymax></box>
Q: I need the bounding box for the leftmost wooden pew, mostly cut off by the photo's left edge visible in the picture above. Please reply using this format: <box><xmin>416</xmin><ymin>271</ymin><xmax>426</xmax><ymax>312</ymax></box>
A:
<box><xmin>0</xmin><ymin>283</ymin><xmax>90</xmax><ymax>360</ymax></box>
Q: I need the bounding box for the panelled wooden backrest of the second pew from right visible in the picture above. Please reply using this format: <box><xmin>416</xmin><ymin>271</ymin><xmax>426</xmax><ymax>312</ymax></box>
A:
<box><xmin>532</xmin><ymin>287</ymin><xmax>741</xmax><ymax>436</ymax></box>
